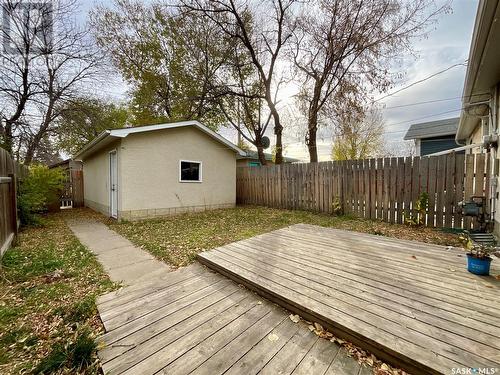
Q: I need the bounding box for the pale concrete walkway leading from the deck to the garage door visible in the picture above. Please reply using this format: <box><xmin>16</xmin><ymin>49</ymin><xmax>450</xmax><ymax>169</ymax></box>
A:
<box><xmin>68</xmin><ymin>220</ymin><xmax>171</xmax><ymax>285</ymax></box>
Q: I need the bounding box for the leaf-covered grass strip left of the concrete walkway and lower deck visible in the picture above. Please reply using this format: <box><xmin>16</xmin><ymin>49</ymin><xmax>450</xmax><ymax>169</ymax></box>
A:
<box><xmin>0</xmin><ymin>214</ymin><xmax>115</xmax><ymax>374</ymax></box>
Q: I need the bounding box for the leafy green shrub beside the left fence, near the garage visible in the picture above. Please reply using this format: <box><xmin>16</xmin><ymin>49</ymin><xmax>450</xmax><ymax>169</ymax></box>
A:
<box><xmin>18</xmin><ymin>165</ymin><xmax>64</xmax><ymax>225</ymax></box>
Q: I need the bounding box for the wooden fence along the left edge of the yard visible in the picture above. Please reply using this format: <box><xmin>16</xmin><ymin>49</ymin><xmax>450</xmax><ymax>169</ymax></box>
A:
<box><xmin>0</xmin><ymin>148</ymin><xmax>28</xmax><ymax>258</ymax></box>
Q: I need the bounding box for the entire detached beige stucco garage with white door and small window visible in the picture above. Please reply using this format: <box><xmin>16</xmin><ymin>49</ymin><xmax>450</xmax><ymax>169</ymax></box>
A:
<box><xmin>75</xmin><ymin>121</ymin><xmax>245</xmax><ymax>220</ymax></box>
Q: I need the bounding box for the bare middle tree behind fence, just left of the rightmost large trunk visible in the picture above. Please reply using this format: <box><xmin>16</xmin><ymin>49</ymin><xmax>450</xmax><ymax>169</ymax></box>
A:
<box><xmin>182</xmin><ymin>0</ymin><xmax>297</xmax><ymax>164</ymax></box>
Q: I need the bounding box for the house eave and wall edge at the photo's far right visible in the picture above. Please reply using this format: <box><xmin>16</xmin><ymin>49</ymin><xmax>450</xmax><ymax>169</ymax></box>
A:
<box><xmin>456</xmin><ymin>0</ymin><xmax>500</xmax><ymax>234</ymax></box>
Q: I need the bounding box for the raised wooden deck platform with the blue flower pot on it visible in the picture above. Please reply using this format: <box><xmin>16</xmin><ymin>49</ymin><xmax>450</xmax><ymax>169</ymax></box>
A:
<box><xmin>198</xmin><ymin>224</ymin><xmax>500</xmax><ymax>374</ymax></box>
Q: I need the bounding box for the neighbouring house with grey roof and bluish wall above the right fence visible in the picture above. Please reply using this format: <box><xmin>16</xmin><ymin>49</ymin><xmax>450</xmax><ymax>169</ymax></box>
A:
<box><xmin>404</xmin><ymin>117</ymin><xmax>460</xmax><ymax>156</ymax></box>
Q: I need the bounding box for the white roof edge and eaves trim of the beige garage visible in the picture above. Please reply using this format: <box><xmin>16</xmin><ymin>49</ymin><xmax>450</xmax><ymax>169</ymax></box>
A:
<box><xmin>74</xmin><ymin>120</ymin><xmax>246</xmax><ymax>160</ymax></box>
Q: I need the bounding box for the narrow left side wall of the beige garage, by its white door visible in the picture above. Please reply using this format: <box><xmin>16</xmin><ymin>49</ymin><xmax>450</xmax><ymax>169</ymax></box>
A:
<box><xmin>83</xmin><ymin>141</ymin><xmax>121</xmax><ymax>216</ymax></box>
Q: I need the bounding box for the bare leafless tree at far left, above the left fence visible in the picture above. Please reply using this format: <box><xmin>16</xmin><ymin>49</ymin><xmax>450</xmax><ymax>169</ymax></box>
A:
<box><xmin>0</xmin><ymin>0</ymin><xmax>102</xmax><ymax>164</ymax></box>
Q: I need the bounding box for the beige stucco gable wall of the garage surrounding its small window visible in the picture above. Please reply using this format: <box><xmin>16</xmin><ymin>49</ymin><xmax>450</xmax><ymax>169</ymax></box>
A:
<box><xmin>118</xmin><ymin>127</ymin><xmax>236</xmax><ymax>220</ymax></box>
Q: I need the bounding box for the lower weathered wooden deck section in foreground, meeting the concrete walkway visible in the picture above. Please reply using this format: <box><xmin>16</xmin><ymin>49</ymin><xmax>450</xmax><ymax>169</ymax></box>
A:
<box><xmin>98</xmin><ymin>264</ymin><xmax>366</xmax><ymax>375</ymax></box>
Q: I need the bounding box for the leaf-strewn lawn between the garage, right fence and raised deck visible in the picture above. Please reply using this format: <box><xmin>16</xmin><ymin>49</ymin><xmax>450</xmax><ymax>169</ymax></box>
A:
<box><xmin>107</xmin><ymin>206</ymin><xmax>460</xmax><ymax>267</ymax></box>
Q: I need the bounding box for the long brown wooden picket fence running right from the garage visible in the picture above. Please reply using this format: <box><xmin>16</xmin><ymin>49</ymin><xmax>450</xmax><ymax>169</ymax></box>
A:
<box><xmin>236</xmin><ymin>153</ymin><xmax>491</xmax><ymax>229</ymax></box>
